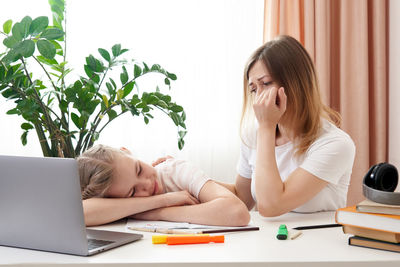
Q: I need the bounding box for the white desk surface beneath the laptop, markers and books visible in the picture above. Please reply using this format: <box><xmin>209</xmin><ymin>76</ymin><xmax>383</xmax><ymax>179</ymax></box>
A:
<box><xmin>0</xmin><ymin>212</ymin><xmax>400</xmax><ymax>267</ymax></box>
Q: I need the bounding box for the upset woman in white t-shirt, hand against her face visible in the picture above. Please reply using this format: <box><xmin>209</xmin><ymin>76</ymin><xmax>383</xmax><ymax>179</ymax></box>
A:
<box><xmin>226</xmin><ymin>36</ymin><xmax>355</xmax><ymax>217</ymax></box>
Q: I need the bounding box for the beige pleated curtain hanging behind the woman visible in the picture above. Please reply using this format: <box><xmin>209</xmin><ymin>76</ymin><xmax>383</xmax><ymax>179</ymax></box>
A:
<box><xmin>264</xmin><ymin>0</ymin><xmax>388</xmax><ymax>205</ymax></box>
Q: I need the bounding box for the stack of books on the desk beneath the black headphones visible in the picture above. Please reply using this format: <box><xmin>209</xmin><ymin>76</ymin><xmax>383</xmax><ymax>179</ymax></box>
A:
<box><xmin>335</xmin><ymin>200</ymin><xmax>400</xmax><ymax>252</ymax></box>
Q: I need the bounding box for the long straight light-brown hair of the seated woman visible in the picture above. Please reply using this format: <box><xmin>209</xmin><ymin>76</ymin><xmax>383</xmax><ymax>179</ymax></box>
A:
<box><xmin>240</xmin><ymin>35</ymin><xmax>341</xmax><ymax>156</ymax></box>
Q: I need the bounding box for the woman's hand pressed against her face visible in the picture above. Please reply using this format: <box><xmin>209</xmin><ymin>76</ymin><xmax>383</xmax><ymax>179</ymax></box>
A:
<box><xmin>253</xmin><ymin>87</ymin><xmax>287</xmax><ymax>128</ymax></box>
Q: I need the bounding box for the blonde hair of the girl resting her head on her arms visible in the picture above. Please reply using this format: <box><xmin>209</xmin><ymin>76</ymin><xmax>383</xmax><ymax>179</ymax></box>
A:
<box><xmin>76</xmin><ymin>145</ymin><xmax>124</xmax><ymax>199</ymax></box>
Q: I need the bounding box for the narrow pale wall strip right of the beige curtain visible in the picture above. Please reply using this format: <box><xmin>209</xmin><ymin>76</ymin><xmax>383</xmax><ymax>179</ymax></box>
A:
<box><xmin>389</xmin><ymin>0</ymin><xmax>400</xmax><ymax>172</ymax></box>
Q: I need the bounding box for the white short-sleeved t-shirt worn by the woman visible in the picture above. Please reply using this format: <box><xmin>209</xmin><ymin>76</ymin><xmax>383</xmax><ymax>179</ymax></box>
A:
<box><xmin>237</xmin><ymin>120</ymin><xmax>355</xmax><ymax>212</ymax></box>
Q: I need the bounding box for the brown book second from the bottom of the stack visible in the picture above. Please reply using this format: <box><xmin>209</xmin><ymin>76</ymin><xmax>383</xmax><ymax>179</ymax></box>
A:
<box><xmin>343</xmin><ymin>225</ymin><xmax>400</xmax><ymax>243</ymax></box>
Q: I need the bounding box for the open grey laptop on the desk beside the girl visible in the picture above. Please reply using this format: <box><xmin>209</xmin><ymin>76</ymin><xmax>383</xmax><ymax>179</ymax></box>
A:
<box><xmin>0</xmin><ymin>155</ymin><xmax>143</xmax><ymax>256</ymax></box>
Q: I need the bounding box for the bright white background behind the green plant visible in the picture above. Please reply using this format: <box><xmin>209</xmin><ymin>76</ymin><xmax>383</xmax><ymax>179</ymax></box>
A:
<box><xmin>0</xmin><ymin>0</ymin><xmax>264</xmax><ymax>181</ymax></box>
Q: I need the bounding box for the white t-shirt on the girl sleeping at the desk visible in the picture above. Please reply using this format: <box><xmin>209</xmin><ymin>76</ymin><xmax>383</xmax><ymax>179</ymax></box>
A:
<box><xmin>155</xmin><ymin>159</ymin><xmax>211</xmax><ymax>198</ymax></box>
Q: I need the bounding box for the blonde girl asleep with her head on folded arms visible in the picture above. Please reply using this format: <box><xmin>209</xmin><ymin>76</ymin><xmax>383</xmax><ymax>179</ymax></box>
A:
<box><xmin>77</xmin><ymin>145</ymin><xmax>250</xmax><ymax>226</ymax></box>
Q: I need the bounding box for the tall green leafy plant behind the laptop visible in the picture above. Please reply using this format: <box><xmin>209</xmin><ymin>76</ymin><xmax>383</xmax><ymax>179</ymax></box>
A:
<box><xmin>0</xmin><ymin>0</ymin><xmax>186</xmax><ymax>158</ymax></box>
